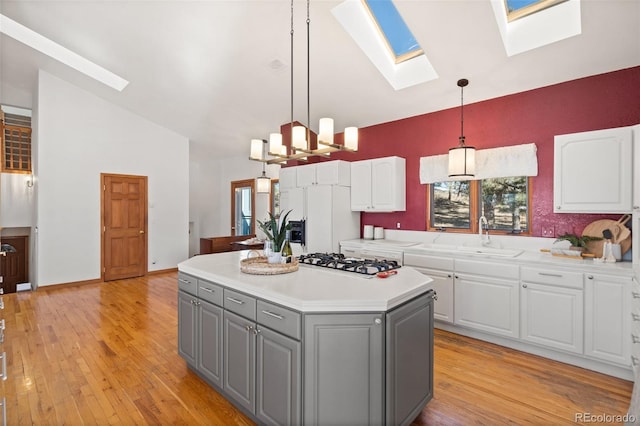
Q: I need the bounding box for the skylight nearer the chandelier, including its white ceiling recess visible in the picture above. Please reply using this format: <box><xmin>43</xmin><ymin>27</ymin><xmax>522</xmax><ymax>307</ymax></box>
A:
<box><xmin>331</xmin><ymin>0</ymin><xmax>438</xmax><ymax>90</ymax></box>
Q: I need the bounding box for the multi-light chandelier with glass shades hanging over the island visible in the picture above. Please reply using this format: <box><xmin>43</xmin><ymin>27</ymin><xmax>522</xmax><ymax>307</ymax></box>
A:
<box><xmin>249</xmin><ymin>0</ymin><xmax>358</xmax><ymax>166</ymax></box>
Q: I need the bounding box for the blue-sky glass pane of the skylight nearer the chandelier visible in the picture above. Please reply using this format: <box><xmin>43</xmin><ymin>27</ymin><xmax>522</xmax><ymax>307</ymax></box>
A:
<box><xmin>362</xmin><ymin>0</ymin><xmax>423</xmax><ymax>64</ymax></box>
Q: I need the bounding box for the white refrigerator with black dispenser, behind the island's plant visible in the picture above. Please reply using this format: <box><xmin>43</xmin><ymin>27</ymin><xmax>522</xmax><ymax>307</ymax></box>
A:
<box><xmin>280</xmin><ymin>185</ymin><xmax>360</xmax><ymax>255</ymax></box>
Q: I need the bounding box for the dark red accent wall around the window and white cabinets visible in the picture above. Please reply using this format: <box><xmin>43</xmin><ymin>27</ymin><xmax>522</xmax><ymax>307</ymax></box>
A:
<box><xmin>292</xmin><ymin>67</ymin><xmax>640</xmax><ymax>236</ymax></box>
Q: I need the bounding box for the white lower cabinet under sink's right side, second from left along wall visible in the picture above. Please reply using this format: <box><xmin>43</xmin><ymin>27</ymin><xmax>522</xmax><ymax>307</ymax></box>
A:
<box><xmin>454</xmin><ymin>260</ymin><xmax>519</xmax><ymax>338</ymax></box>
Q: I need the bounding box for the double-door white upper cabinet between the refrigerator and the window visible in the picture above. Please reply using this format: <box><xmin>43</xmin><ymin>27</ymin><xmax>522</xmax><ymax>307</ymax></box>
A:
<box><xmin>351</xmin><ymin>157</ymin><xmax>406</xmax><ymax>212</ymax></box>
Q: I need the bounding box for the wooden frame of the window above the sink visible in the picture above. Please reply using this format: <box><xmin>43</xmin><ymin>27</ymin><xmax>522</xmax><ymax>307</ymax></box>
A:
<box><xmin>426</xmin><ymin>176</ymin><xmax>533</xmax><ymax>236</ymax></box>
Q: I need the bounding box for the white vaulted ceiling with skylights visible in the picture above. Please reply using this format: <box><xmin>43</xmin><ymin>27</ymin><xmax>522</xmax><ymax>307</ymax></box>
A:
<box><xmin>0</xmin><ymin>0</ymin><xmax>640</xmax><ymax>157</ymax></box>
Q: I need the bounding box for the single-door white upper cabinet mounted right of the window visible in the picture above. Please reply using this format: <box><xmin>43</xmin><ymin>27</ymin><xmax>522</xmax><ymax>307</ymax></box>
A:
<box><xmin>553</xmin><ymin>127</ymin><xmax>633</xmax><ymax>213</ymax></box>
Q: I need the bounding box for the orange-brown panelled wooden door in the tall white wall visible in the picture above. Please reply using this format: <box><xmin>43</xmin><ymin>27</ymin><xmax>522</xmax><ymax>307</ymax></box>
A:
<box><xmin>101</xmin><ymin>174</ymin><xmax>147</xmax><ymax>281</ymax></box>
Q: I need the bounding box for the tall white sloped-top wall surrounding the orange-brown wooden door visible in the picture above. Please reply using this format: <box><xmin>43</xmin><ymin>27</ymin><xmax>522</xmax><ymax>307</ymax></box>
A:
<box><xmin>34</xmin><ymin>71</ymin><xmax>189</xmax><ymax>286</ymax></box>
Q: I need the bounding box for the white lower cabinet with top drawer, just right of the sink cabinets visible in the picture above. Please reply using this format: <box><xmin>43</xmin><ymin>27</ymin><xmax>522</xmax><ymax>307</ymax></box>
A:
<box><xmin>520</xmin><ymin>268</ymin><xmax>584</xmax><ymax>354</ymax></box>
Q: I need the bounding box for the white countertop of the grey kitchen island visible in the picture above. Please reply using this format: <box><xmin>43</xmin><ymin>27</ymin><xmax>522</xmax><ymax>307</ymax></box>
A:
<box><xmin>178</xmin><ymin>251</ymin><xmax>433</xmax><ymax>312</ymax></box>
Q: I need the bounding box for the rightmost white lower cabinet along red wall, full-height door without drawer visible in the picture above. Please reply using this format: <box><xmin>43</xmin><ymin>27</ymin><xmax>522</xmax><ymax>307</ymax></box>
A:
<box><xmin>584</xmin><ymin>274</ymin><xmax>640</xmax><ymax>366</ymax></box>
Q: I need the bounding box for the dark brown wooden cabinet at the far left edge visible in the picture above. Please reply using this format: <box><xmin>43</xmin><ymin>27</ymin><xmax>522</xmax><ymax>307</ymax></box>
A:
<box><xmin>0</xmin><ymin>236</ymin><xmax>29</xmax><ymax>293</ymax></box>
